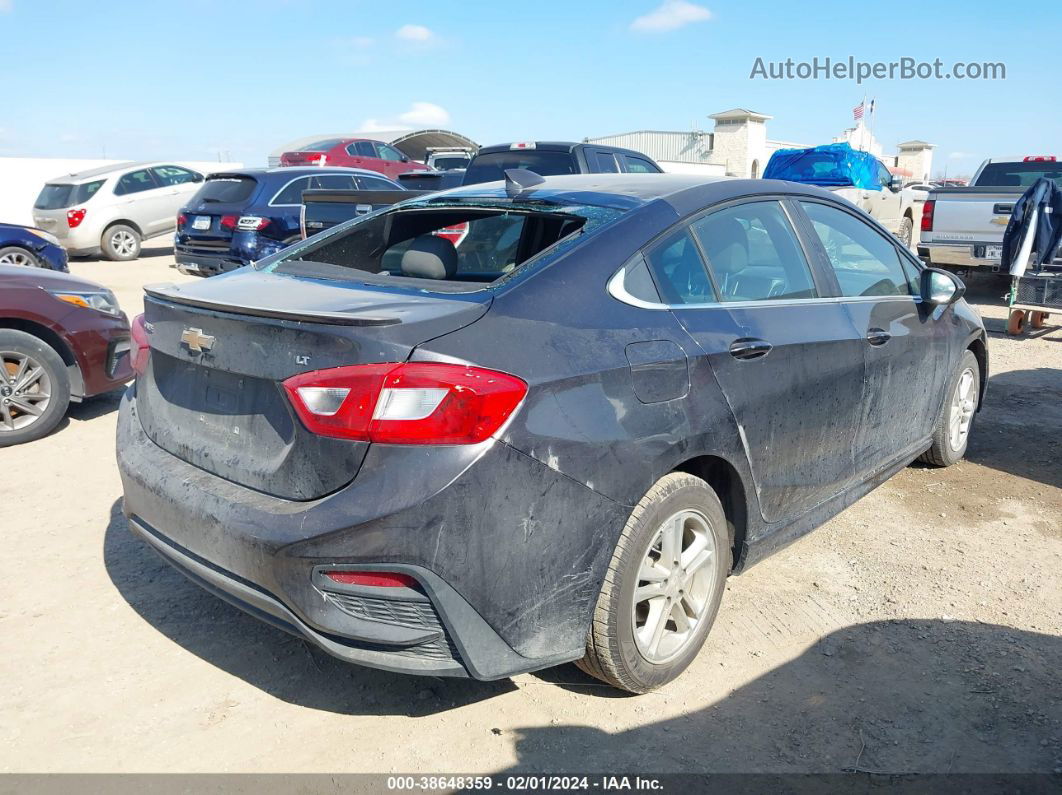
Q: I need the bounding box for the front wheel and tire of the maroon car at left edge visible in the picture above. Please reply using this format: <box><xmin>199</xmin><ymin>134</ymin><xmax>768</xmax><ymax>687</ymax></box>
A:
<box><xmin>0</xmin><ymin>329</ymin><xmax>70</xmax><ymax>447</ymax></box>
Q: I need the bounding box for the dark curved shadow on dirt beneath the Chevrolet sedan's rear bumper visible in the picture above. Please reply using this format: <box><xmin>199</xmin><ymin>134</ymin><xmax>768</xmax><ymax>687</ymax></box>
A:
<box><xmin>103</xmin><ymin>500</ymin><xmax>515</xmax><ymax>716</ymax></box>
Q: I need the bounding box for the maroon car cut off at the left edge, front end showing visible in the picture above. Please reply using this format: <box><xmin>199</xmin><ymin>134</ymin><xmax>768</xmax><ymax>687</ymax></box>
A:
<box><xmin>0</xmin><ymin>265</ymin><xmax>133</xmax><ymax>447</ymax></box>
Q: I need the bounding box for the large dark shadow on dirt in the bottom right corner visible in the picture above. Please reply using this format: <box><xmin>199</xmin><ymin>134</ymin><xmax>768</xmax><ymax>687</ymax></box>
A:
<box><xmin>501</xmin><ymin>620</ymin><xmax>1062</xmax><ymax>774</ymax></box>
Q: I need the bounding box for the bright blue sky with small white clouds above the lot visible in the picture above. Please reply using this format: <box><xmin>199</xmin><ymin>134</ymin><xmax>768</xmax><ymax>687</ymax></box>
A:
<box><xmin>0</xmin><ymin>0</ymin><xmax>1062</xmax><ymax>174</ymax></box>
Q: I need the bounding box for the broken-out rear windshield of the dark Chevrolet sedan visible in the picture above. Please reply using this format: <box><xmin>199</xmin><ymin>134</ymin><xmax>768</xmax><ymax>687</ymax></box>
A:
<box><xmin>263</xmin><ymin>205</ymin><xmax>621</xmax><ymax>289</ymax></box>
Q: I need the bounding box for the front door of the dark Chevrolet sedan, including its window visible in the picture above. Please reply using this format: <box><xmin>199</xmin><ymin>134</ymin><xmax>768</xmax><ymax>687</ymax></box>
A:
<box><xmin>800</xmin><ymin>200</ymin><xmax>948</xmax><ymax>464</ymax></box>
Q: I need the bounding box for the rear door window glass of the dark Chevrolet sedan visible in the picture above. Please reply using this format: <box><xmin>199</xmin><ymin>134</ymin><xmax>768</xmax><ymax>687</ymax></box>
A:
<box><xmin>692</xmin><ymin>202</ymin><xmax>818</xmax><ymax>301</ymax></box>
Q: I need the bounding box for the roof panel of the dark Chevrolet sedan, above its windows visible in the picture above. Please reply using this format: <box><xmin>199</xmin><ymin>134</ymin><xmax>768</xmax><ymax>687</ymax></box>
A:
<box><xmin>432</xmin><ymin>173</ymin><xmax>838</xmax><ymax>215</ymax></box>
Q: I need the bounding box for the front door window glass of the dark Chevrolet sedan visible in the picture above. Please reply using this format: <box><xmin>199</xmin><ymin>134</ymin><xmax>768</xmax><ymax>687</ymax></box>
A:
<box><xmin>801</xmin><ymin>202</ymin><xmax>917</xmax><ymax>297</ymax></box>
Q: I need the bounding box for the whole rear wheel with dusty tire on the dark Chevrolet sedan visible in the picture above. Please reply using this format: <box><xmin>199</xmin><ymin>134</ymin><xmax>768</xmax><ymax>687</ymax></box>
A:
<box><xmin>576</xmin><ymin>472</ymin><xmax>731</xmax><ymax>693</ymax></box>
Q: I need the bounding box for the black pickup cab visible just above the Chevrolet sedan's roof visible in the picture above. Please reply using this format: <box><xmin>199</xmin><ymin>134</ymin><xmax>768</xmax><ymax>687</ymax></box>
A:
<box><xmin>462</xmin><ymin>141</ymin><xmax>662</xmax><ymax>185</ymax></box>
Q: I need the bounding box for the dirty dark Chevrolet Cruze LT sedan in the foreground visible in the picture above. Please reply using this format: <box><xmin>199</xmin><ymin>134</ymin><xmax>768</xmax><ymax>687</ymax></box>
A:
<box><xmin>118</xmin><ymin>172</ymin><xmax>988</xmax><ymax>692</ymax></box>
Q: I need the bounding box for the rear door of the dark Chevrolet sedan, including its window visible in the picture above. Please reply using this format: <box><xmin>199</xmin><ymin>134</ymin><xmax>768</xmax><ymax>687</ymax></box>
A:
<box><xmin>647</xmin><ymin>201</ymin><xmax>864</xmax><ymax>522</ymax></box>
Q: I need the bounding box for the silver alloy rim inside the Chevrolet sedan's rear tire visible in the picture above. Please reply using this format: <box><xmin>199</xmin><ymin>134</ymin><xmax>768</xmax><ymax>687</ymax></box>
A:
<box><xmin>631</xmin><ymin>511</ymin><xmax>717</xmax><ymax>664</ymax></box>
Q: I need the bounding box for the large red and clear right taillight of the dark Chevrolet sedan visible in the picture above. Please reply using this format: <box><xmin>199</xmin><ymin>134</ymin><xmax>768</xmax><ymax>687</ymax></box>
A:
<box><xmin>284</xmin><ymin>362</ymin><xmax>528</xmax><ymax>445</ymax></box>
